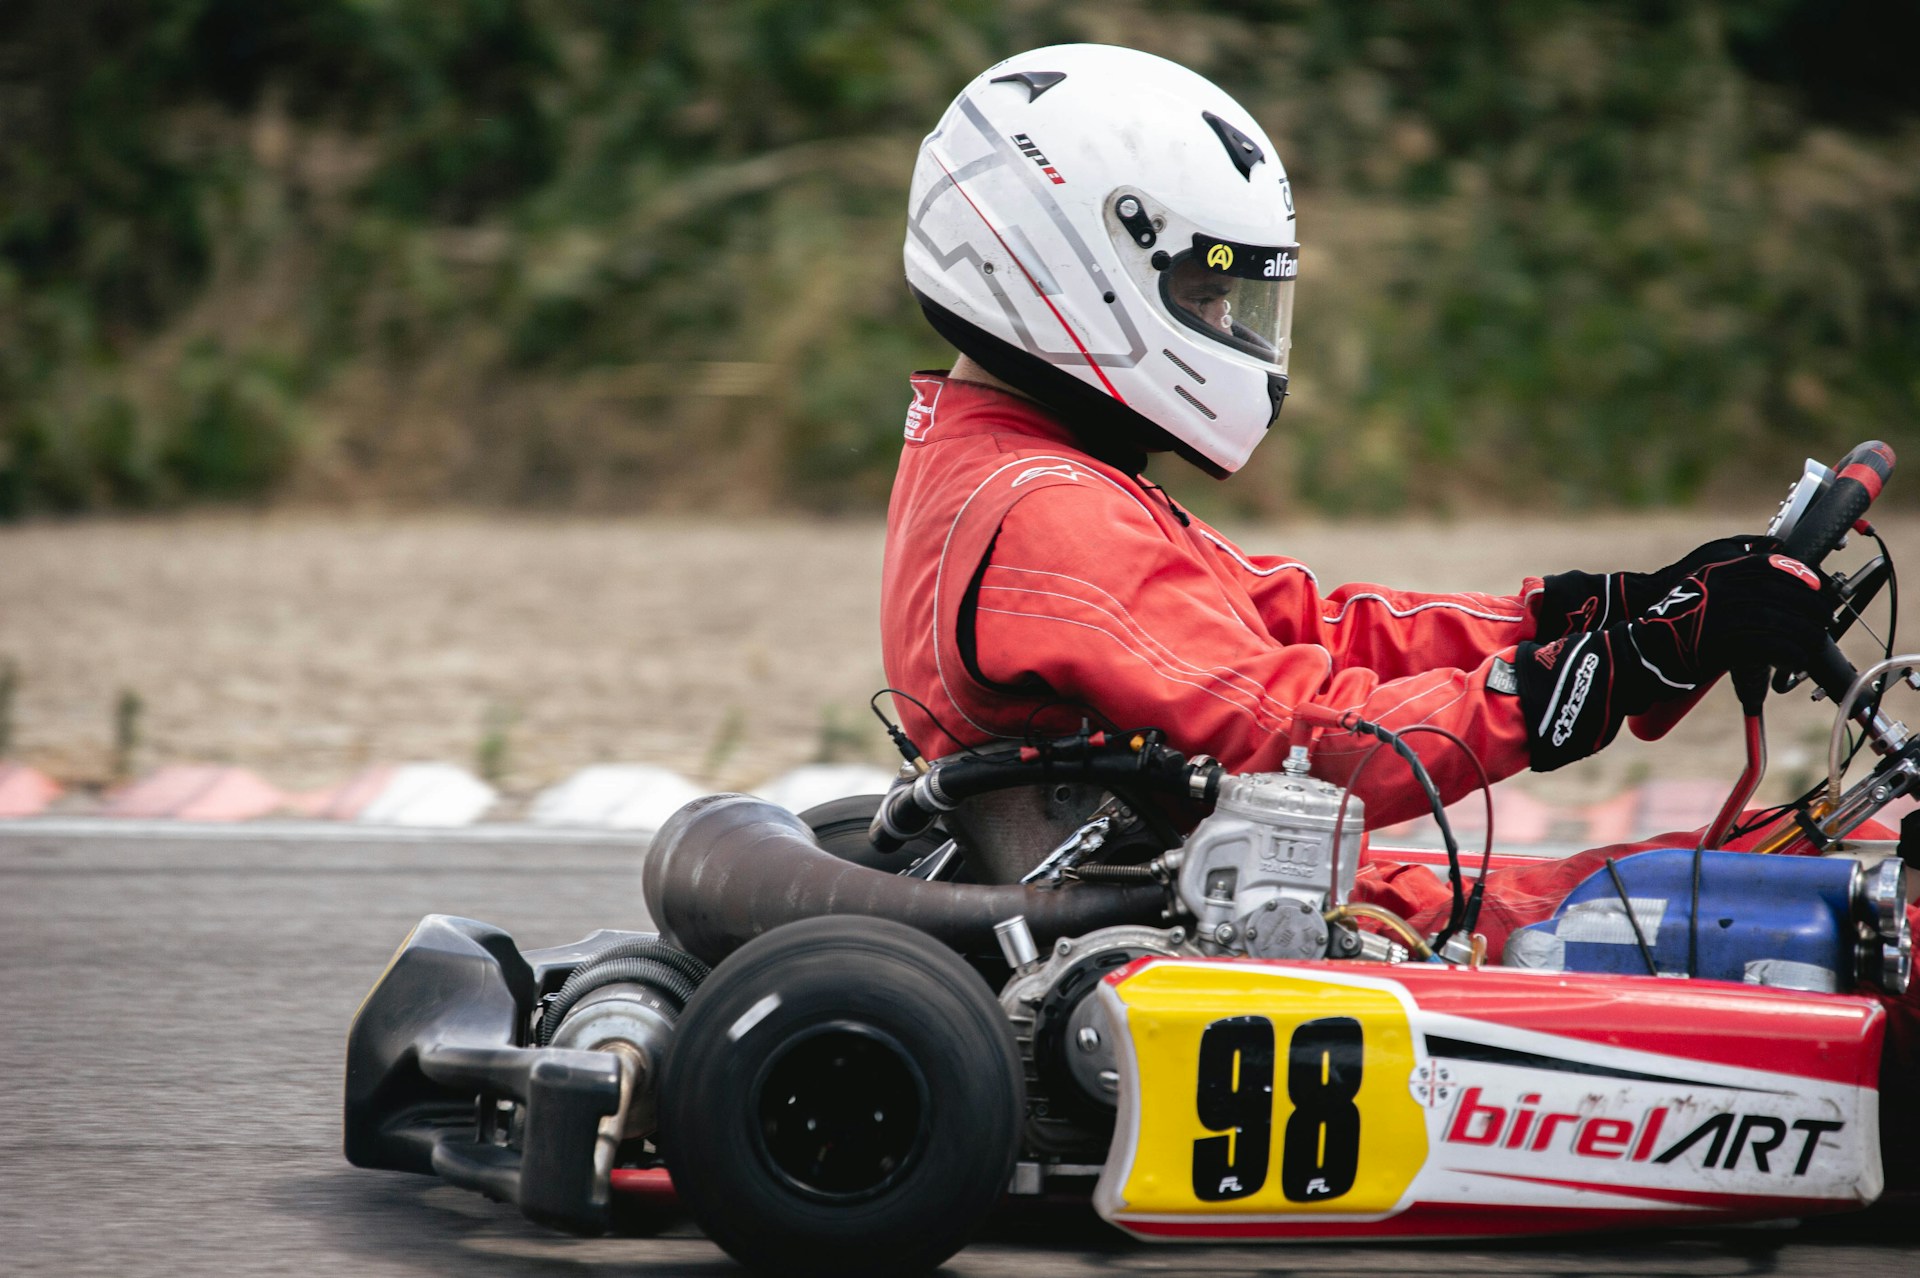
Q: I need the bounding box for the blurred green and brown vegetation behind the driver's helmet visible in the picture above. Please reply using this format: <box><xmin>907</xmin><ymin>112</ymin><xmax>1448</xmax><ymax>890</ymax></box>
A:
<box><xmin>0</xmin><ymin>0</ymin><xmax>1920</xmax><ymax>518</ymax></box>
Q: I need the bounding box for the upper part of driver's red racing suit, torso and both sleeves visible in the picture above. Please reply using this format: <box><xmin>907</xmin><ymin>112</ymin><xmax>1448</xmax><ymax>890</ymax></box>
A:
<box><xmin>881</xmin><ymin>374</ymin><xmax>1540</xmax><ymax>825</ymax></box>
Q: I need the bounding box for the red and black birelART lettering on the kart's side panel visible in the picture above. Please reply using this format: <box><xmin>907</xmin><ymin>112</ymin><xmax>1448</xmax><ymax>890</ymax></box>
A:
<box><xmin>1446</xmin><ymin>1088</ymin><xmax>1847</xmax><ymax>1176</ymax></box>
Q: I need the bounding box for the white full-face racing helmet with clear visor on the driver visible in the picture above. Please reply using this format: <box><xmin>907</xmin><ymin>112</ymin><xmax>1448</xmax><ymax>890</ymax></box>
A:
<box><xmin>906</xmin><ymin>44</ymin><xmax>1300</xmax><ymax>476</ymax></box>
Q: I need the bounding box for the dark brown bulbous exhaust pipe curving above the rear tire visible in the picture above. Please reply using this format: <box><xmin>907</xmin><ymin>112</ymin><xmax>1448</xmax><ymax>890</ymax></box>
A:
<box><xmin>641</xmin><ymin>794</ymin><xmax>1165</xmax><ymax>963</ymax></box>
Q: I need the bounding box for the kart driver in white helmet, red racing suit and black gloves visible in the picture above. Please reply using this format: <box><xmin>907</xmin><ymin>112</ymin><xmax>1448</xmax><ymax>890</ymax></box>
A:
<box><xmin>881</xmin><ymin>44</ymin><xmax>1858</xmax><ymax>958</ymax></box>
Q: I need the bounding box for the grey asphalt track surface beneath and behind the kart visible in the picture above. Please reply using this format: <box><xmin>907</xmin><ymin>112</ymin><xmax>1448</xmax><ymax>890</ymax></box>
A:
<box><xmin>0</xmin><ymin>827</ymin><xmax>1920</xmax><ymax>1278</ymax></box>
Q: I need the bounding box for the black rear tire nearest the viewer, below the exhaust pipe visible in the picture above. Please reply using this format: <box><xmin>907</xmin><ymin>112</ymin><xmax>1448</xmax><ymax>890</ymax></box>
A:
<box><xmin>659</xmin><ymin>917</ymin><xmax>1025</xmax><ymax>1278</ymax></box>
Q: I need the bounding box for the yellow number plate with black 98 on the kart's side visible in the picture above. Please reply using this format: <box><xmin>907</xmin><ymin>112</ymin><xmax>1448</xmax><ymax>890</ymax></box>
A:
<box><xmin>1108</xmin><ymin>961</ymin><xmax>1427</xmax><ymax>1217</ymax></box>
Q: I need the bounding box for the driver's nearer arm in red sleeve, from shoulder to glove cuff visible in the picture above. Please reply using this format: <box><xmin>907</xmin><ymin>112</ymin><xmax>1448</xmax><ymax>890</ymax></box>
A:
<box><xmin>973</xmin><ymin>485</ymin><xmax>1528</xmax><ymax>825</ymax></box>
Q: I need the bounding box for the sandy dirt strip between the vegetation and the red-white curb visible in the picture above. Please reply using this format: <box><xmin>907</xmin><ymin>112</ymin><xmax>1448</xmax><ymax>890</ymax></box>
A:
<box><xmin>0</xmin><ymin>499</ymin><xmax>1920</xmax><ymax>802</ymax></box>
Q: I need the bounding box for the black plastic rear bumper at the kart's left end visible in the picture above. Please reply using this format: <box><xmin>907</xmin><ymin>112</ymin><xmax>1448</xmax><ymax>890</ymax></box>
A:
<box><xmin>346</xmin><ymin>913</ymin><xmax>630</xmax><ymax>1234</ymax></box>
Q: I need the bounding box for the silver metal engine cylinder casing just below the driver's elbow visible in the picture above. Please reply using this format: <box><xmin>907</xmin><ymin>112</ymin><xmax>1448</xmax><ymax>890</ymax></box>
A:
<box><xmin>1177</xmin><ymin>771</ymin><xmax>1367</xmax><ymax>959</ymax></box>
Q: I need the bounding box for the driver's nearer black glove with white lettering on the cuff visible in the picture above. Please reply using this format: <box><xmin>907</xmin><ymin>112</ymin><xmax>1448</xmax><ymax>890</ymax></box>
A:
<box><xmin>1515</xmin><ymin>547</ymin><xmax>1834</xmax><ymax>771</ymax></box>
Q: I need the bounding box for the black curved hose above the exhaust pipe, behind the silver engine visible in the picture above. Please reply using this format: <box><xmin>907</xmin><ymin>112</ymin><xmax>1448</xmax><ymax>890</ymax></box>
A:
<box><xmin>868</xmin><ymin>727</ymin><xmax>1225</xmax><ymax>852</ymax></box>
